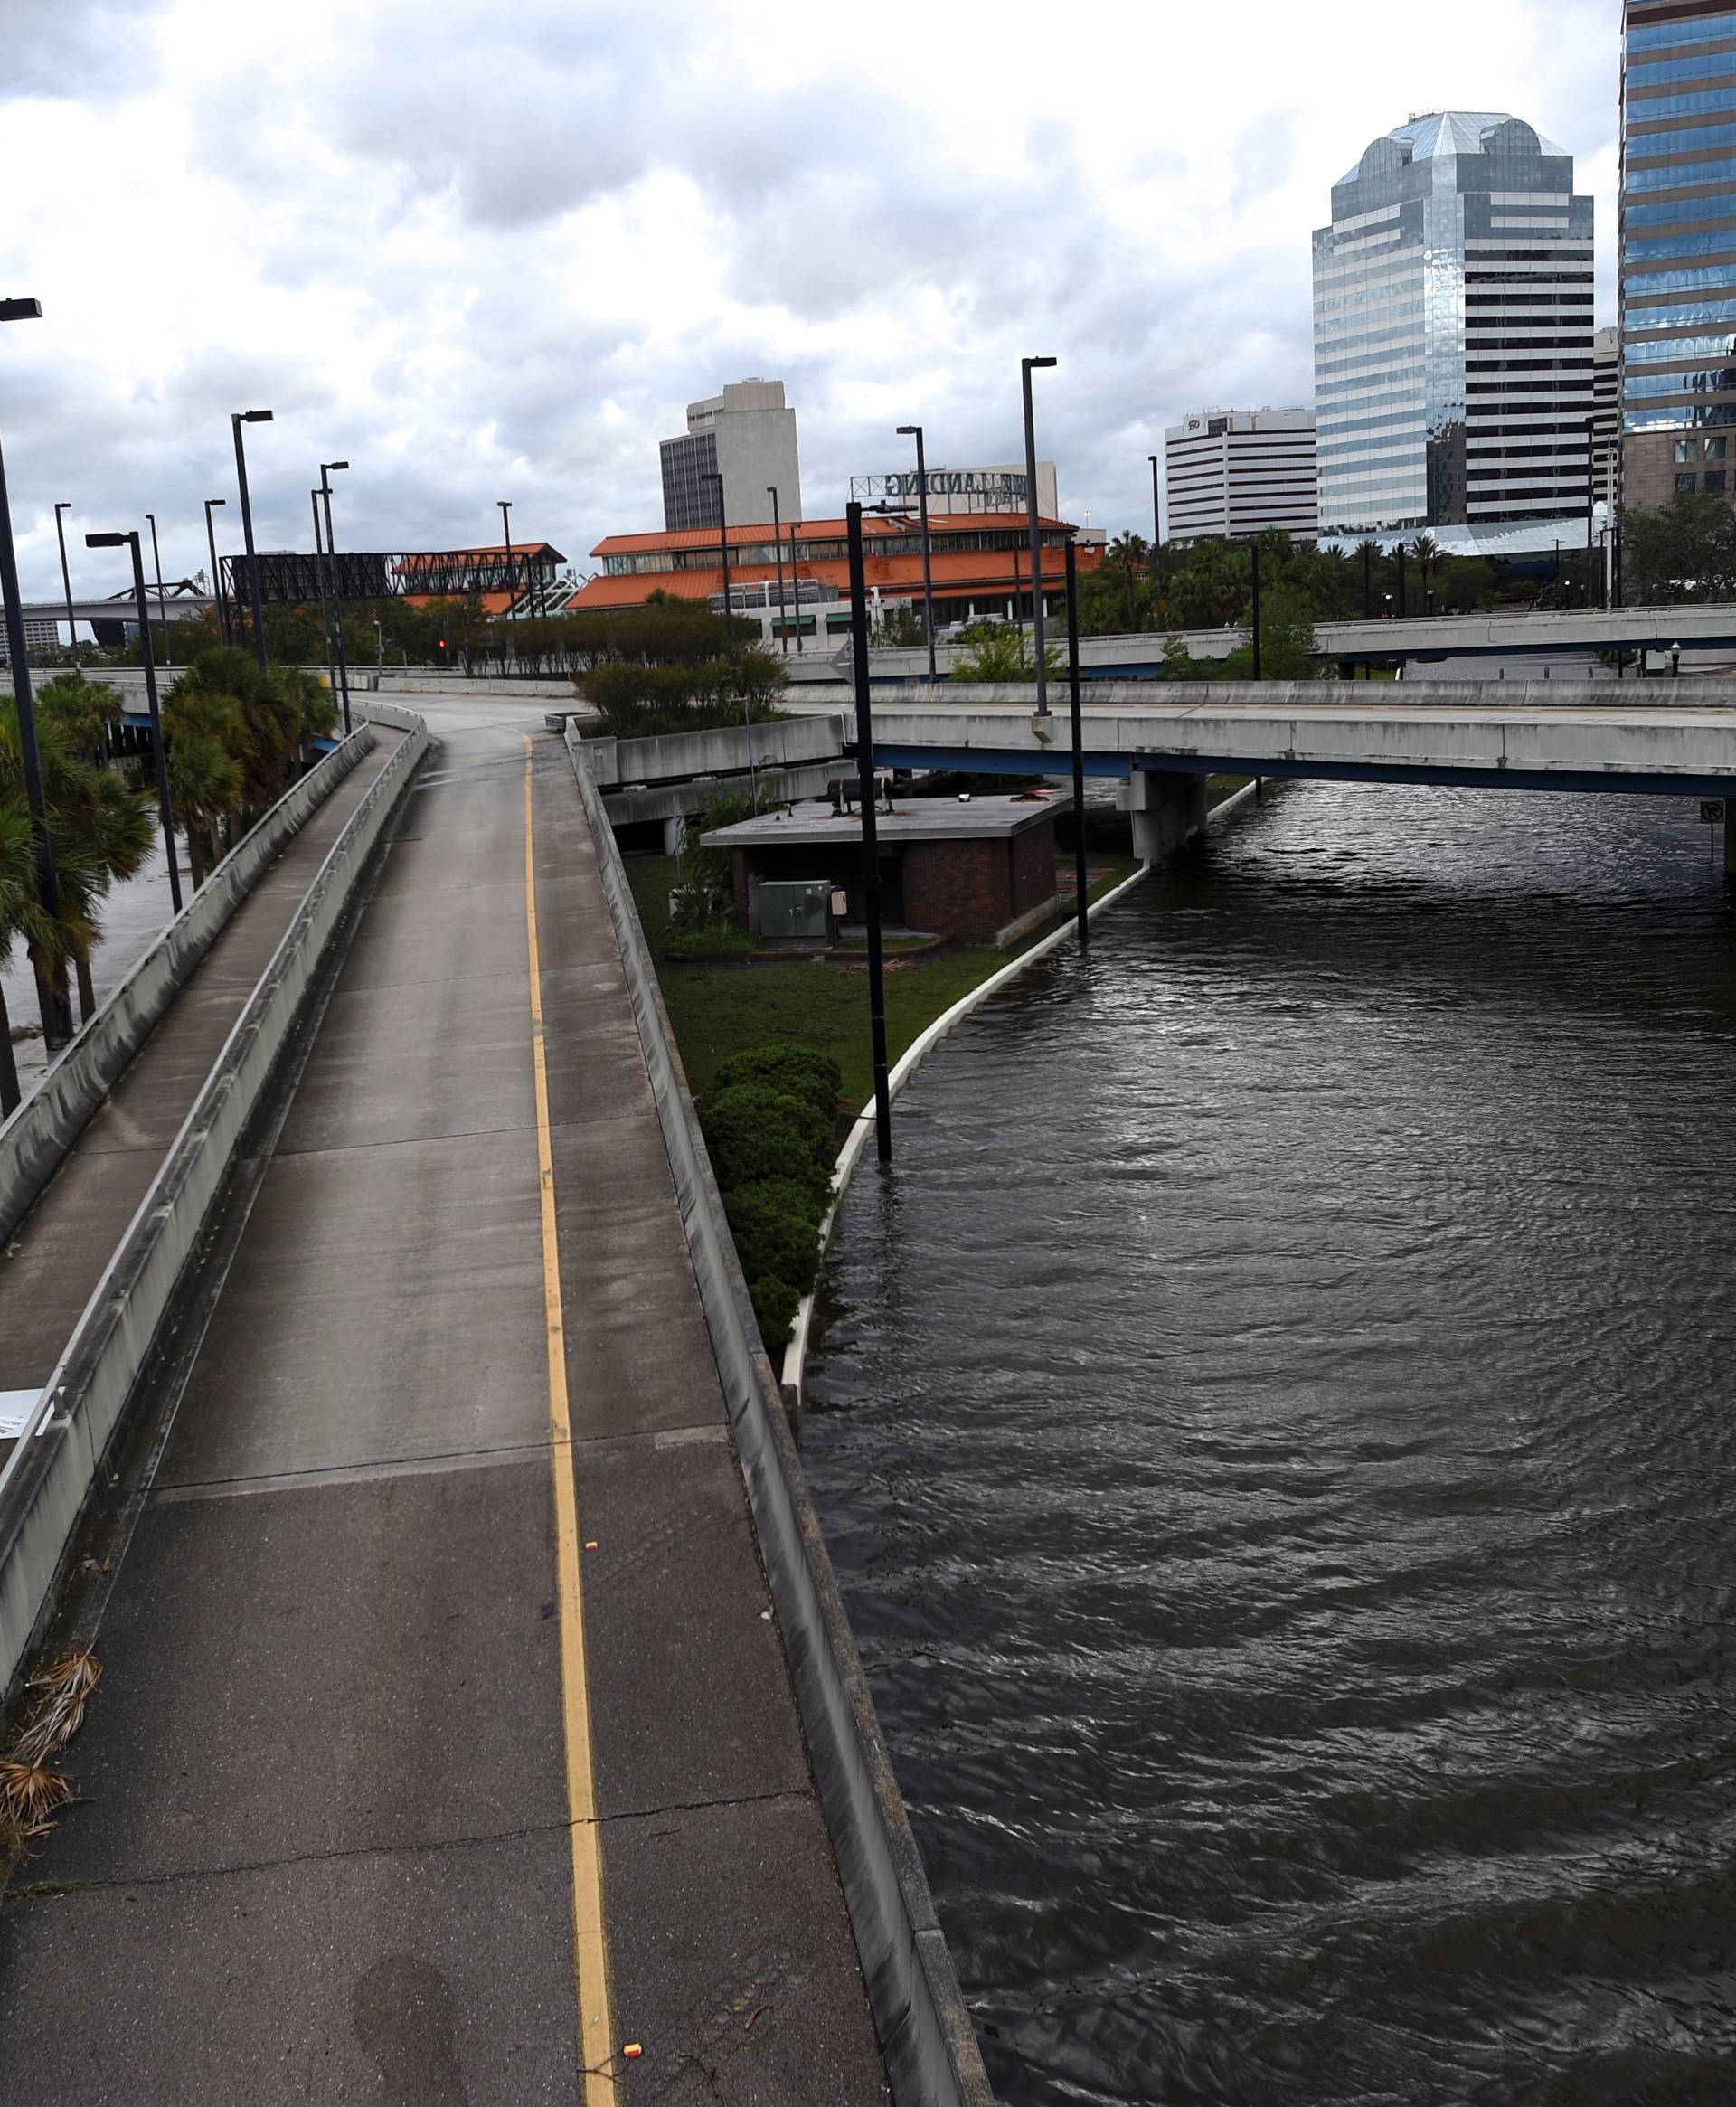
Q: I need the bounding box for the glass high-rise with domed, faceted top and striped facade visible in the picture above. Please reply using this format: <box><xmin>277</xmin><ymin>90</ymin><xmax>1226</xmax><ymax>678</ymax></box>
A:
<box><xmin>1315</xmin><ymin>109</ymin><xmax>1593</xmax><ymax>552</ymax></box>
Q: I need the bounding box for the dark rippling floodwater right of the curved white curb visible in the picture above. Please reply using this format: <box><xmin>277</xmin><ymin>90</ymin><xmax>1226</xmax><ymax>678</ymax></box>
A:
<box><xmin>803</xmin><ymin>784</ymin><xmax>1736</xmax><ymax>2107</ymax></box>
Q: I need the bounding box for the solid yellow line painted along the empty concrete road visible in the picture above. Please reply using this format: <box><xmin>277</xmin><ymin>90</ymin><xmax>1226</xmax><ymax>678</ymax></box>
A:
<box><xmin>524</xmin><ymin>740</ymin><xmax>619</xmax><ymax>2107</ymax></box>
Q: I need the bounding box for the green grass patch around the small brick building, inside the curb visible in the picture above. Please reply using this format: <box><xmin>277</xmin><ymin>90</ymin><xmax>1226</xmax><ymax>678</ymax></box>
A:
<box><xmin>626</xmin><ymin>855</ymin><xmax>1137</xmax><ymax>1110</ymax></box>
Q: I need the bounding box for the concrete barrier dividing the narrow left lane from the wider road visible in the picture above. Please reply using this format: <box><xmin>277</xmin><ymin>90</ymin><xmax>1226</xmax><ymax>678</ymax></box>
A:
<box><xmin>0</xmin><ymin>729</ymin><xmax>428</xmax><ymax>1690</ymax></box>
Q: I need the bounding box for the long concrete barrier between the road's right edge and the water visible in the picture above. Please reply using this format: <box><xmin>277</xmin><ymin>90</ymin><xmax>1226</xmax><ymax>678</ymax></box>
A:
<box><xmin>567</xmin><ymin>732</ymin><xmax>992</xmax><ymax>2107</ymax></box>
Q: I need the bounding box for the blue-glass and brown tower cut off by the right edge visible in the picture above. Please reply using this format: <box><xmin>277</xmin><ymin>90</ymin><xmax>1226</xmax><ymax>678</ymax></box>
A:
<box><xmin>1620</xmin><ymin>0</ymin><xmax>1736</xmax><ymax>505</ymax></box>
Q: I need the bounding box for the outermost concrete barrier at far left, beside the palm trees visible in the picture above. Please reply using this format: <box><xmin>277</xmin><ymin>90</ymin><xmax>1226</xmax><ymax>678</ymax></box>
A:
<box><xmin>0</xmin><ymin>732</ymin><xmax>373</xmax><ymax>1241</ymax></box>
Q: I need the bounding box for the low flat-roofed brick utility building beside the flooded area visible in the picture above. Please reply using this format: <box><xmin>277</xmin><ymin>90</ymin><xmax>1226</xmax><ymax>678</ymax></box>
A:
<box><xmin>703</xmin><ymin>790</ymin><xmax>1072</xmax><ymax>944</ymax></box>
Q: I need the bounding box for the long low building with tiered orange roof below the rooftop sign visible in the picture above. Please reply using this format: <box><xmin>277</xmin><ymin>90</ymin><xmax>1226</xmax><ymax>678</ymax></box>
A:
<box><xmin>567</xmin><ymin>510</ymin><xmax>1104</xmax><ymax>637</ymax></box>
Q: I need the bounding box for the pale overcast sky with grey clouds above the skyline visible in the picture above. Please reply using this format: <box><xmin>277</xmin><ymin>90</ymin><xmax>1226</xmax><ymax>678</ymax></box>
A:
<box><xmin>0</xmin><ymin>0</ymin><xmax>1620</xmax><ymax>596</ymax></box>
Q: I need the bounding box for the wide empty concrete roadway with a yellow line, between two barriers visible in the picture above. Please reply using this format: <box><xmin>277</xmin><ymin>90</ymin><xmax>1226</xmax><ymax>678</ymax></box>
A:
<box><xmin>0</xmin><ymin>702</ymin><xmax>885</xmax><ymax>2107</ymax></box>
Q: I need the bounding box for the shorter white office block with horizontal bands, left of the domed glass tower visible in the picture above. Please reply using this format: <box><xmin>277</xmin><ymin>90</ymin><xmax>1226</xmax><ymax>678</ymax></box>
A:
<box><xmin>1163</xmin><ymin>409</ymin><xmax>1321</xmax><ymax>548</ymax></box>
